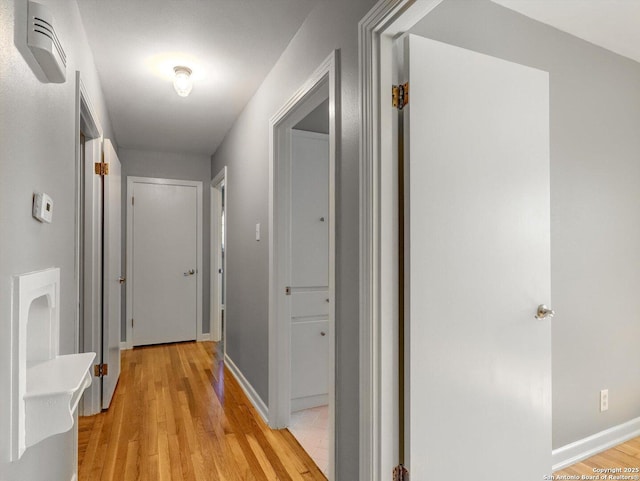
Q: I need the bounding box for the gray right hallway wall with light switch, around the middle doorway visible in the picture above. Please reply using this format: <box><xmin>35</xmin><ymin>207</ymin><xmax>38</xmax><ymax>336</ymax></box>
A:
<box><xmin>211</xmin><ymin>0</ymin><xmax>375</xmax><ymax>480</ymax></box>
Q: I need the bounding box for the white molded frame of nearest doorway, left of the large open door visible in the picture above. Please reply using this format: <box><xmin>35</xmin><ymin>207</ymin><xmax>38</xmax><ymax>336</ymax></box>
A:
<box><xmin>358</xmin><ymin>0</ymin><xmax>442</xmax><ymax>481</ymax></box>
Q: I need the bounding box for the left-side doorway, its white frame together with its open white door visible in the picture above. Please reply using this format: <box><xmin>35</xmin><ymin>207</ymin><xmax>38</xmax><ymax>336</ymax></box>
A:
<box><xmin>75</xmin><ymin>72</ymin><xmax>125</xmax><ymax>416</ymax></box>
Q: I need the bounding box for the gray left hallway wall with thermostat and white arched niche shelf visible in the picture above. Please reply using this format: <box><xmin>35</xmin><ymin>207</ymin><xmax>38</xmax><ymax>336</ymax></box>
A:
<box><xmin>0</xmin><ymin>0</ymin><xmax>113</xmax><ymax>474</ymax></box>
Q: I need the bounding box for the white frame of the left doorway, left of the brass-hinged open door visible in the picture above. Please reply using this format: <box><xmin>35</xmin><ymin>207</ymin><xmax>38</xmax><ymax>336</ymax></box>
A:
<box><xmin>74</xmin><ymin>71</ymin><xmax>103</xmax><ymax>416</ymax></box>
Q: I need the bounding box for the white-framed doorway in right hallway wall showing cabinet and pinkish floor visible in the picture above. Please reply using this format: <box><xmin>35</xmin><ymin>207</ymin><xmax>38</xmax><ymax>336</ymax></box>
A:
<box><xmin>269</xmin><ymin>52</ymin><xmax>340</xmax><ymax>480</ymax></box>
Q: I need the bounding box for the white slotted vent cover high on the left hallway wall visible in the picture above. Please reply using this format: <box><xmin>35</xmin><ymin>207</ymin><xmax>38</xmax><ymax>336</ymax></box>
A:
<box><xmin>27</xmin><ymin>2</ymin><xmax>67</xmax><ymax>83</ymax></box>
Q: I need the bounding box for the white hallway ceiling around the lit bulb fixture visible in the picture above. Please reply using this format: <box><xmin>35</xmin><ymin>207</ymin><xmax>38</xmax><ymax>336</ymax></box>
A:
<box><xmin>78</xmin><ymin>0</ymin><xmax>317</xmax><ymax>154</ymax></box>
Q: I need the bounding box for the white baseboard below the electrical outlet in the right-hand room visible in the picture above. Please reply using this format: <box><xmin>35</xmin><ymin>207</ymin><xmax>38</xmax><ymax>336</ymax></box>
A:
<box><xmin>552</xmin><ymin>418</ymin><xmax>640</xmax><ymax>471</ymax></box>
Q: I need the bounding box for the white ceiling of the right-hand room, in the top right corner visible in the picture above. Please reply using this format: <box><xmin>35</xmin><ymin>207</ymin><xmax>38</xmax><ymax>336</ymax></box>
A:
<box><xmin>492</xmin><ymin>0</ymin><xmax>640</xmax><ymax>62</ymax></box>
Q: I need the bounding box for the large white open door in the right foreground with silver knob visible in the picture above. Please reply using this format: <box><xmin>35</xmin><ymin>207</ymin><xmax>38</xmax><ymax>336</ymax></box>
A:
<box><xmin>404</xmin><ymin>36</ymin><xmax>551</xmax><ymax>481</ymax></box>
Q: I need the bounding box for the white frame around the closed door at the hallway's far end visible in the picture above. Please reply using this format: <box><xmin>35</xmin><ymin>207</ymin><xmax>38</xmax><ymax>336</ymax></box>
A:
<box><xmin>125</xmin><ymin>176</ymin><xmax>208</xmax><ymax>349</ymax></box>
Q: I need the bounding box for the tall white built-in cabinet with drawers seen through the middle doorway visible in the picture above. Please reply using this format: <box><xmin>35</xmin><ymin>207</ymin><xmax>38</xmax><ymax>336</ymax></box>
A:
<box><xmin>290</xmin><ymin>130</ymin><xmax>330</xmax><ymax>412</ymax></box>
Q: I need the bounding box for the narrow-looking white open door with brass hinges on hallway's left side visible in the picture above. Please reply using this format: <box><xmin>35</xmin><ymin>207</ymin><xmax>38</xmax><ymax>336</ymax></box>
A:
<box><xmin>102</xmin><ymin>139</ymin><xmax>124</xmax><ymax>409</ymax></box>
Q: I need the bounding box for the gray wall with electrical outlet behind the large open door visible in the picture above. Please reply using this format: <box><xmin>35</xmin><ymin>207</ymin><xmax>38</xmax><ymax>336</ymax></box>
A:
<box><xmin>413</xmin><ymin>0</ymin><xmax>640</xmax><ymax>448</ymax></box>
